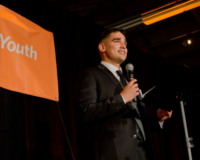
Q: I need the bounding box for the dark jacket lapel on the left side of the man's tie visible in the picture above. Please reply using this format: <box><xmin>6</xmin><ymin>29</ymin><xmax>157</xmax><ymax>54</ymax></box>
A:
<box><xmin>97</xmin><ymin>64</ymin><xmax>123</xmax><ymax>92</ymax></box>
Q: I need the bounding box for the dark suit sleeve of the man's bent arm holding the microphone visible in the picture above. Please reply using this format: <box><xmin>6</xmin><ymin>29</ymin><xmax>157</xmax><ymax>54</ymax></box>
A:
<box><xmin>75</xmin><ymin>70</ymin><xmax>128</xmax><ymax>123</ymax></box>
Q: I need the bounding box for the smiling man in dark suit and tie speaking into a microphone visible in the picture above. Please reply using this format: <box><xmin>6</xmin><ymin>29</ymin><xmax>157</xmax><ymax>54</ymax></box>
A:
<box><xmin>75</xmin><ymin>28</ymin><xmax>172</xmax><ymax>160</ymax></box>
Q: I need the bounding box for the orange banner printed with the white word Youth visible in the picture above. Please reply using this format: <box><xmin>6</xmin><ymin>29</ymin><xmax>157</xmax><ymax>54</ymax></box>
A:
<box><xmin>0</xmin><ymin>5</ymin><xmax>59</xmax><ymax>101</ymax></box>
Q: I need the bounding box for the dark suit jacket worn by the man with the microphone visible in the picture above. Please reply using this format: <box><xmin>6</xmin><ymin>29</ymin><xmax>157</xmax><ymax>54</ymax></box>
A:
<box><xmin>75</xmin><ymin>64</ymin><xmax>160</xmax><ymax>160</ymax></box>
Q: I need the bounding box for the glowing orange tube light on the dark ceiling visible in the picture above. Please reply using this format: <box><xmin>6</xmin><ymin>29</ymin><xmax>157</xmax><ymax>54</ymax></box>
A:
<box><xmin>142</xmin><ymin>0</ymin><xmax>200</xmax><ymax>25</ymax></box>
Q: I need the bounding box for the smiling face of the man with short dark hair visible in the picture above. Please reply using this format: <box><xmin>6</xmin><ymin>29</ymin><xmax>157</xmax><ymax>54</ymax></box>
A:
<box><xmin>104</xmin><ymin>32</ymin><xmax>128</xmax><ymax>65</ymax></box>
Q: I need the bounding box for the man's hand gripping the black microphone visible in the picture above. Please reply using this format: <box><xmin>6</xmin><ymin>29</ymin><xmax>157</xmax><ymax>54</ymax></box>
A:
<box><xmin>120</xmin><ymin>79</ymin><xmax>139</xmax><ymax>103</ymax></box>
